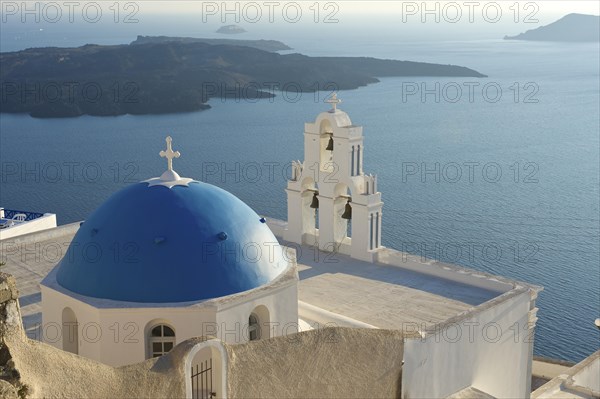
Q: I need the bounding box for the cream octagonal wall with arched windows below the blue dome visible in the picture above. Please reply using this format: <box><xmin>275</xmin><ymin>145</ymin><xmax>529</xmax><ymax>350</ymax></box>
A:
<box><xmin>41</xmin><ymin>269</ymin><xmax>298</xmax><ymax>366</ymax></box>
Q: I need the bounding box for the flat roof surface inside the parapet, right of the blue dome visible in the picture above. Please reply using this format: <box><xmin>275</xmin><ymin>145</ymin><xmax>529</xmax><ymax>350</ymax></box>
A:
<box><xmin>290</xmin><ymin>242</ymin><xmax>502</xmax><ymax>329</ymax></box>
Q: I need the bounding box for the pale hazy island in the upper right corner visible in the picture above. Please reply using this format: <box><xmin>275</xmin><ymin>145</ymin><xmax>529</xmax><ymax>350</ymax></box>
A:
<box><xmin>504</xmin><ymin>14</ymin><xmax>600</xmax><ymax>42</ymax></box>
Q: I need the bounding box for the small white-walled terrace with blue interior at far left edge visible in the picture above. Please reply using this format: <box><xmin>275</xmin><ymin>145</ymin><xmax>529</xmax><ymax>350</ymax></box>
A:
<box><xmin>0</xmin><ymin>208</ymin><xmax>56</xmax><ymax>241</ymax></box>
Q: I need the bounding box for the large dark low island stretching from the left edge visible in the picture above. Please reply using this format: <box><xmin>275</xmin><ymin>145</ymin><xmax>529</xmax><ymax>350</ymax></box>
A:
<box><xmin>0</xmin><ymin>39</ymin><xmax>485</xmax><ymax>118</ymax></box>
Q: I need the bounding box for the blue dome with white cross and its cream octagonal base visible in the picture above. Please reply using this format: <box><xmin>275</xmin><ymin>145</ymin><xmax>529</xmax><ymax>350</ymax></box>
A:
<box><xmin>41</xmin><ymin>137</ymin><xmax>298</xmax><ymax>368</ymax></box>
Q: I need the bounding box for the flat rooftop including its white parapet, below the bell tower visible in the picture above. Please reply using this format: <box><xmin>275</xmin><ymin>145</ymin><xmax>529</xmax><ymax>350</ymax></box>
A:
<box><xmin>267</xmin><ymin>219</ymin><xmax>542</xmax><ymax>331</ymax></box>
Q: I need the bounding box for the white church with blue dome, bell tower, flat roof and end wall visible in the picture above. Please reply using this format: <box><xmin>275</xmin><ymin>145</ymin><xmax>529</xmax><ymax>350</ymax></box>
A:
<box><xmin>29</xmin><ymin>96</ymin><xmax>552</xmax><ymax>398</ymax></box>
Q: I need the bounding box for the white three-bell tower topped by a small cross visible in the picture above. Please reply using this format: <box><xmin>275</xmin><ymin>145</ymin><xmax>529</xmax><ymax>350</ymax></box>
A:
<box><xmin>284</xmin><ymin>93</ymin><xmax>383</xmax><ymax>262</ymax></box>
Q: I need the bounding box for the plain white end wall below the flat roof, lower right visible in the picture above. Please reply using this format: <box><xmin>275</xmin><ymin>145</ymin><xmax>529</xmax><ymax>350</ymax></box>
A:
<box><xmin>402</xmin><ymin>289</ymin><xmax>537</xmax><ymax>399</ymax></box>
